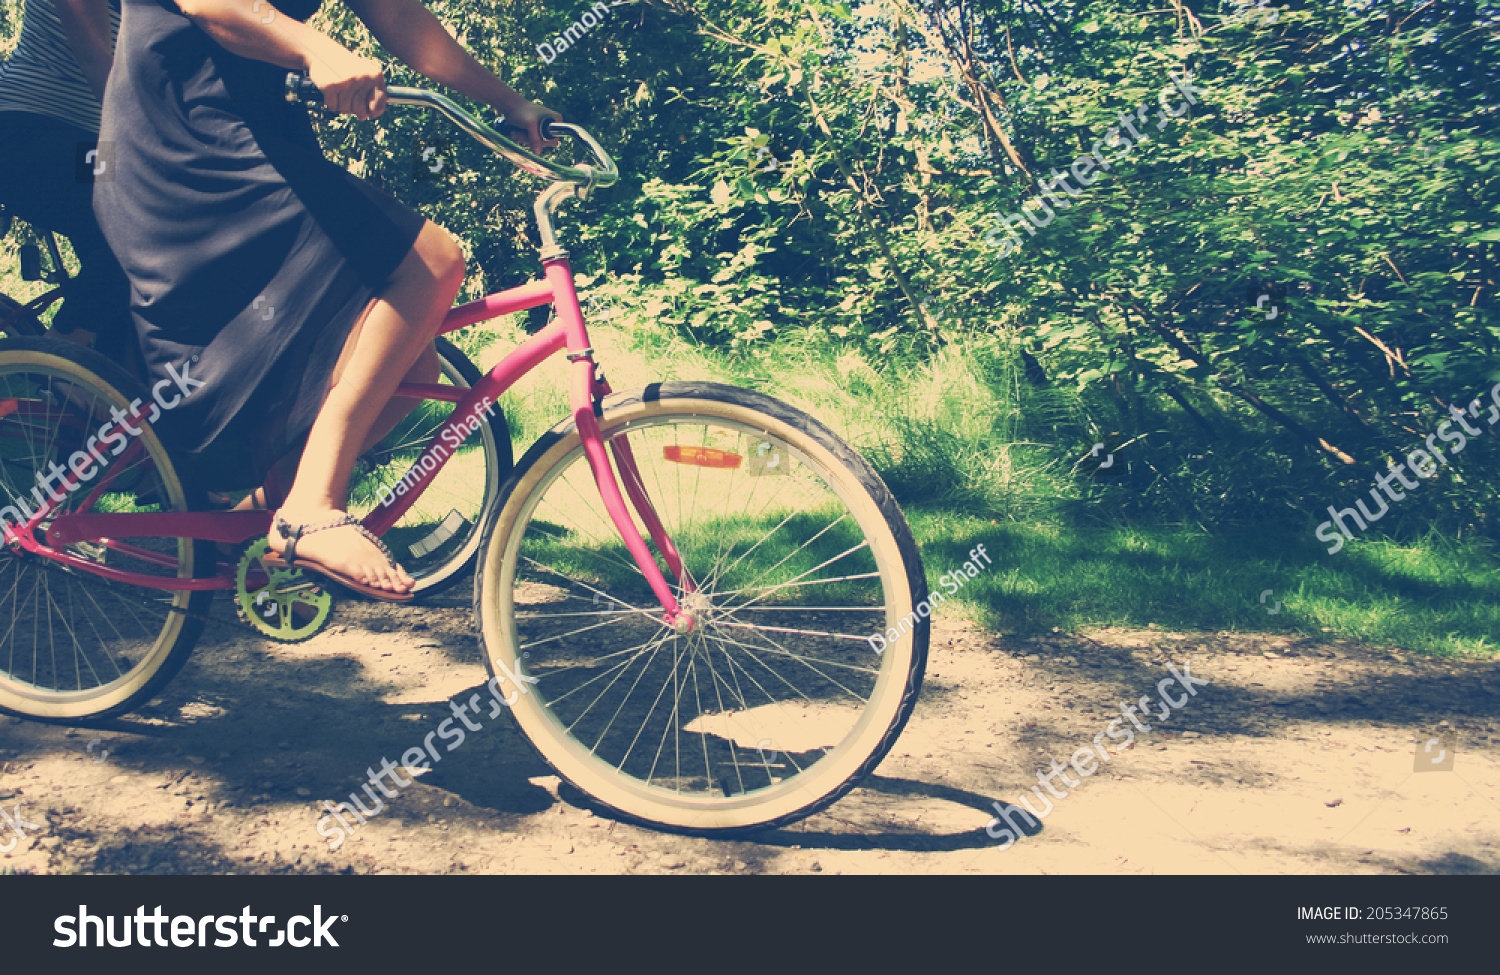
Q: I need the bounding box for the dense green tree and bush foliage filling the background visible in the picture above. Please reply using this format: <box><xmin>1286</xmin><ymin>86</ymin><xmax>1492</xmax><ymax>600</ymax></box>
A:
<box><xmin>11</xmin><ymin>0</ymin><xmax>1500</xmax><ymax>534</ymax></box>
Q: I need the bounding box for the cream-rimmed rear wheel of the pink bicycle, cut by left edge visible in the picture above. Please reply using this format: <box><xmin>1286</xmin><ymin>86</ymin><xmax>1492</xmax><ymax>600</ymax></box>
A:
<box><xmin>0</xmin><ymin>339</ymin><xmax>215</xmax><ymax>723</ymax></box>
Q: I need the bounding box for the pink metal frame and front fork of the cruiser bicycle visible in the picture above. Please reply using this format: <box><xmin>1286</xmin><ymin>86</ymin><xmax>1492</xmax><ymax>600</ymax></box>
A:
<box><xmin>29</xmin><ymin>255</ymin><xmax>693</xmax><ymax>627</ymax></box>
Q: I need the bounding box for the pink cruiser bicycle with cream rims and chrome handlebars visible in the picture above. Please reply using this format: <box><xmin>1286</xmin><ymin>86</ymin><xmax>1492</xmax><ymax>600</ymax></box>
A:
<box><xmin>0</xmin><ymin>77</ymin><xmax>929</xmax><ymax>834</ymax></box>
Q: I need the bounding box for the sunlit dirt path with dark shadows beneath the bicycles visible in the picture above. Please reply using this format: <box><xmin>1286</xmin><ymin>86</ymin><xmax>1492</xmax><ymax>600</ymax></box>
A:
<box><xmin>0</xmin><ymin>587</ymin><xmax>1500</xmax><ymax>873</ymax></box>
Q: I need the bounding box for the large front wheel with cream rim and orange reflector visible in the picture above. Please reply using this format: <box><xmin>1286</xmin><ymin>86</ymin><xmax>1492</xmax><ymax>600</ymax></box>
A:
<box><xmin>474</xmin><ymin>383</ymin><xmax>929</xmax><ymax>834</ymax></box>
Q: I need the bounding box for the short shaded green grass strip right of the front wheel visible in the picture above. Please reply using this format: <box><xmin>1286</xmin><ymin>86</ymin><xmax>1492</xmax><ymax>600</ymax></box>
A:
<box><xmin>908</xmin><ymin>509</ymin><xmax>1500</xmax><ymax>659</ymax></box>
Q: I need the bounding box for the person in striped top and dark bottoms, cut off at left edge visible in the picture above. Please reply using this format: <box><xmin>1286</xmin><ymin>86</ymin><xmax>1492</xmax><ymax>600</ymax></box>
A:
<box><xmin>0</xmin><ymin>0</ymin><xmax>135</xmax><ymax>360</ymax></box>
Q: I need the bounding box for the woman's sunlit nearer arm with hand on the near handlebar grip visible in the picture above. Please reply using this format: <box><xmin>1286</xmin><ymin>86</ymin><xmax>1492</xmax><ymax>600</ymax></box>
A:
<box><xmin>176</xmin><ymin>0</ymin><xmax>386</xmax><ymax>119</ymax></box>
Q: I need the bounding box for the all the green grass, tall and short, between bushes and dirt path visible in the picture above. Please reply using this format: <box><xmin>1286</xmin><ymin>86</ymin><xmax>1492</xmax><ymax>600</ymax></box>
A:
<box><xmin>438</xmin><ymin>315</ymin><xmax>1500</xmax><ymax>657</ymax></box>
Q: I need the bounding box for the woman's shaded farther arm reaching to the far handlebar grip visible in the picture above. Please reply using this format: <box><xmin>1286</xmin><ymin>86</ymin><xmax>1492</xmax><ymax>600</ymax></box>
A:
<box><xmin>345</xmin><ymin>0</ymin><xmax>557</xmax><ymax>152</ymax></box>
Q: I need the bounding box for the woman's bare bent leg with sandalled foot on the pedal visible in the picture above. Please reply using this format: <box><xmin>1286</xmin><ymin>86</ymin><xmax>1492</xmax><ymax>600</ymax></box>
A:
<box><xmin>269</xmin><ymin>222</ymin><xmax>464</xmax><ymax>593</ymax></box>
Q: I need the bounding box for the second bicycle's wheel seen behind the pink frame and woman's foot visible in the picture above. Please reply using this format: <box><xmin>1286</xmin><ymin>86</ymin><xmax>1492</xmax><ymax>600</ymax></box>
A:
<box><xmin>348</xmin><ymin>338</ymin><xmax>513</xmax><ymax>596</ymax></box>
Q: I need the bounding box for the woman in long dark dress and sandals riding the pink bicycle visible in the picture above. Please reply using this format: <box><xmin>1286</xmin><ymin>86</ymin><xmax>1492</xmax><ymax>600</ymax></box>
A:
<box><xmin>95</xmin><ymin>0</ymin><xmax>555</xmax><ymax>600</ymax></box>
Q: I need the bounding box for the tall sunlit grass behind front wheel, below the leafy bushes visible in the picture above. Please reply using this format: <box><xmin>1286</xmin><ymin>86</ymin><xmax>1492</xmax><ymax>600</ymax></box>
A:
<box><xmin>450</xmin><ymin>308</ymin><xmax>1082</xmax><ymax>518</ymax></box>
